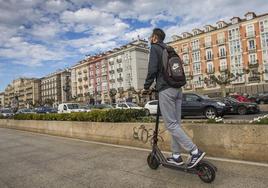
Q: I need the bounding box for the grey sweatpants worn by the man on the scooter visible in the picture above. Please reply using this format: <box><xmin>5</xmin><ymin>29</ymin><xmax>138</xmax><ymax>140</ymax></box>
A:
<box><xmin>159</xmin><ymin>88</ymin><xmax>197</xmax><ymax>154</ymax></box>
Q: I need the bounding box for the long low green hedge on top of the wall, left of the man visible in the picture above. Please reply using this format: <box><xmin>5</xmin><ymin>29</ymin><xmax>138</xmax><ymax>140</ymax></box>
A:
<box><xmin>14</xmin><ymin>109</ymin><xmax>153</xmax><ymax>122</ymax></box>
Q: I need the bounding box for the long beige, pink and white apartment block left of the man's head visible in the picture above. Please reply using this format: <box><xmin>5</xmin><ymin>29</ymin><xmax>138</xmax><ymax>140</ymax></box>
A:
<box><xmin>71</xmin><ymin>39</ymin><xmax>149</xmax><ymax>102</ymax></box>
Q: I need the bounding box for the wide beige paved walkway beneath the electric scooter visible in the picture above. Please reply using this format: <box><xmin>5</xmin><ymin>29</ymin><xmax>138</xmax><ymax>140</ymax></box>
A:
<box><xmin>0</xmin><ymin>128</ymin><xmax>268</xmax><ymax>188</ymax></box>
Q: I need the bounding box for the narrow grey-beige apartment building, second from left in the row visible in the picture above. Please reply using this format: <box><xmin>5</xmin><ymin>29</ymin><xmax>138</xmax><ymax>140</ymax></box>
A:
<box><xmin>41</xmin><ymin>70</ymin><xmax>71</xmax><ymax>106</ymax></box>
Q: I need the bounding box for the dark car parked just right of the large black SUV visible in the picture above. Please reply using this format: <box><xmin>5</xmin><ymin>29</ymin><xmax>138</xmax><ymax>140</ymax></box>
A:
<box><xmin>218</xmin><ymin>97</ymin><xmax>260</xmax><ymax>115</ymax></box>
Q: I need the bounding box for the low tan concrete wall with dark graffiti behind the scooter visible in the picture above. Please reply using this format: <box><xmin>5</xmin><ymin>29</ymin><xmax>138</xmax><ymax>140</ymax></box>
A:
<box><xmin>0</xmin><ymin>119</ymin><xmax>268</xmax><ymax>163</ymax></box>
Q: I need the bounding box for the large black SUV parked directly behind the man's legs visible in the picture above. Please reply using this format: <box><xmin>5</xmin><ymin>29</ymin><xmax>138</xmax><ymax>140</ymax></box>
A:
<box><xmin>182</xmin><ymin>93</ymin><xmax>227</xmax><ymax>119</ymax></box>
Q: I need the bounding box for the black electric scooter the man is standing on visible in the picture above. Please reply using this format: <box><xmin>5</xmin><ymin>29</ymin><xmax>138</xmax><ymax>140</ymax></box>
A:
<box><xmin>147</xmin><ymin>97</ymin><xmax>217</xmax><ymax>183</ymax></box>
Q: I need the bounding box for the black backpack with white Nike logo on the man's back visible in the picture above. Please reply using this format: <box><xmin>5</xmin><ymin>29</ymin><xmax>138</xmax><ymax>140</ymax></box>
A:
<box><xmin>158</xmin><ymin>44</ymin><xmax>186</xmax><ymax>88</ymax></box>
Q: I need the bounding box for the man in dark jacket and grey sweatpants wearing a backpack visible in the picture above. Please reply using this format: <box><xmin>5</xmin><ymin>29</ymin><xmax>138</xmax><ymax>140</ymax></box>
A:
<box><xmin>143</xmin><ymin>28</ymin><xmax>205</xmax><ymax>169</ymax></box>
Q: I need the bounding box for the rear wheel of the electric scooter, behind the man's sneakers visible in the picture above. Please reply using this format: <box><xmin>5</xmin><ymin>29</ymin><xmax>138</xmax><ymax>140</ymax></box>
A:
<box><xmin>196</xmin><ymin>161</ymin><xmax>216</xmax><ymax>183</ymax></box>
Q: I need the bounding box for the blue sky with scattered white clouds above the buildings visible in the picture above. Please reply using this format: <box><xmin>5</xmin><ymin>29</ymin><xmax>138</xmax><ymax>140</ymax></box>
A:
<box><xmin>0</xmin><ymin>0</ymin><xmax>268</xmax><ymax>91</ymax></box>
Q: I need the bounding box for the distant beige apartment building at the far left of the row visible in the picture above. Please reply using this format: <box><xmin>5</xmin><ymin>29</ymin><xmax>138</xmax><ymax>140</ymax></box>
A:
<box><xmin>4</xmin><ymin>78</ymin><xmax>40</xmax><ymax>108</ymax></box>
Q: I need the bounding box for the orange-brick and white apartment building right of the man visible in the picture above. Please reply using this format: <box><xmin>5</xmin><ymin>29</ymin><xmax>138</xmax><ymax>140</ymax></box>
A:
<box><xmin>169</xmin><ymin>12</ymin><xmax>268</xmax><ymax>94</ymax></box>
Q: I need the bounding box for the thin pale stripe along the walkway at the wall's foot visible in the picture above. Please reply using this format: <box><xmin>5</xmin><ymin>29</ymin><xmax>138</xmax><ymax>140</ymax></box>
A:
<box><xmin>0</xmin><ymin>127</ymin><xmax>268</xmax><ymax>167</ymax></box>
